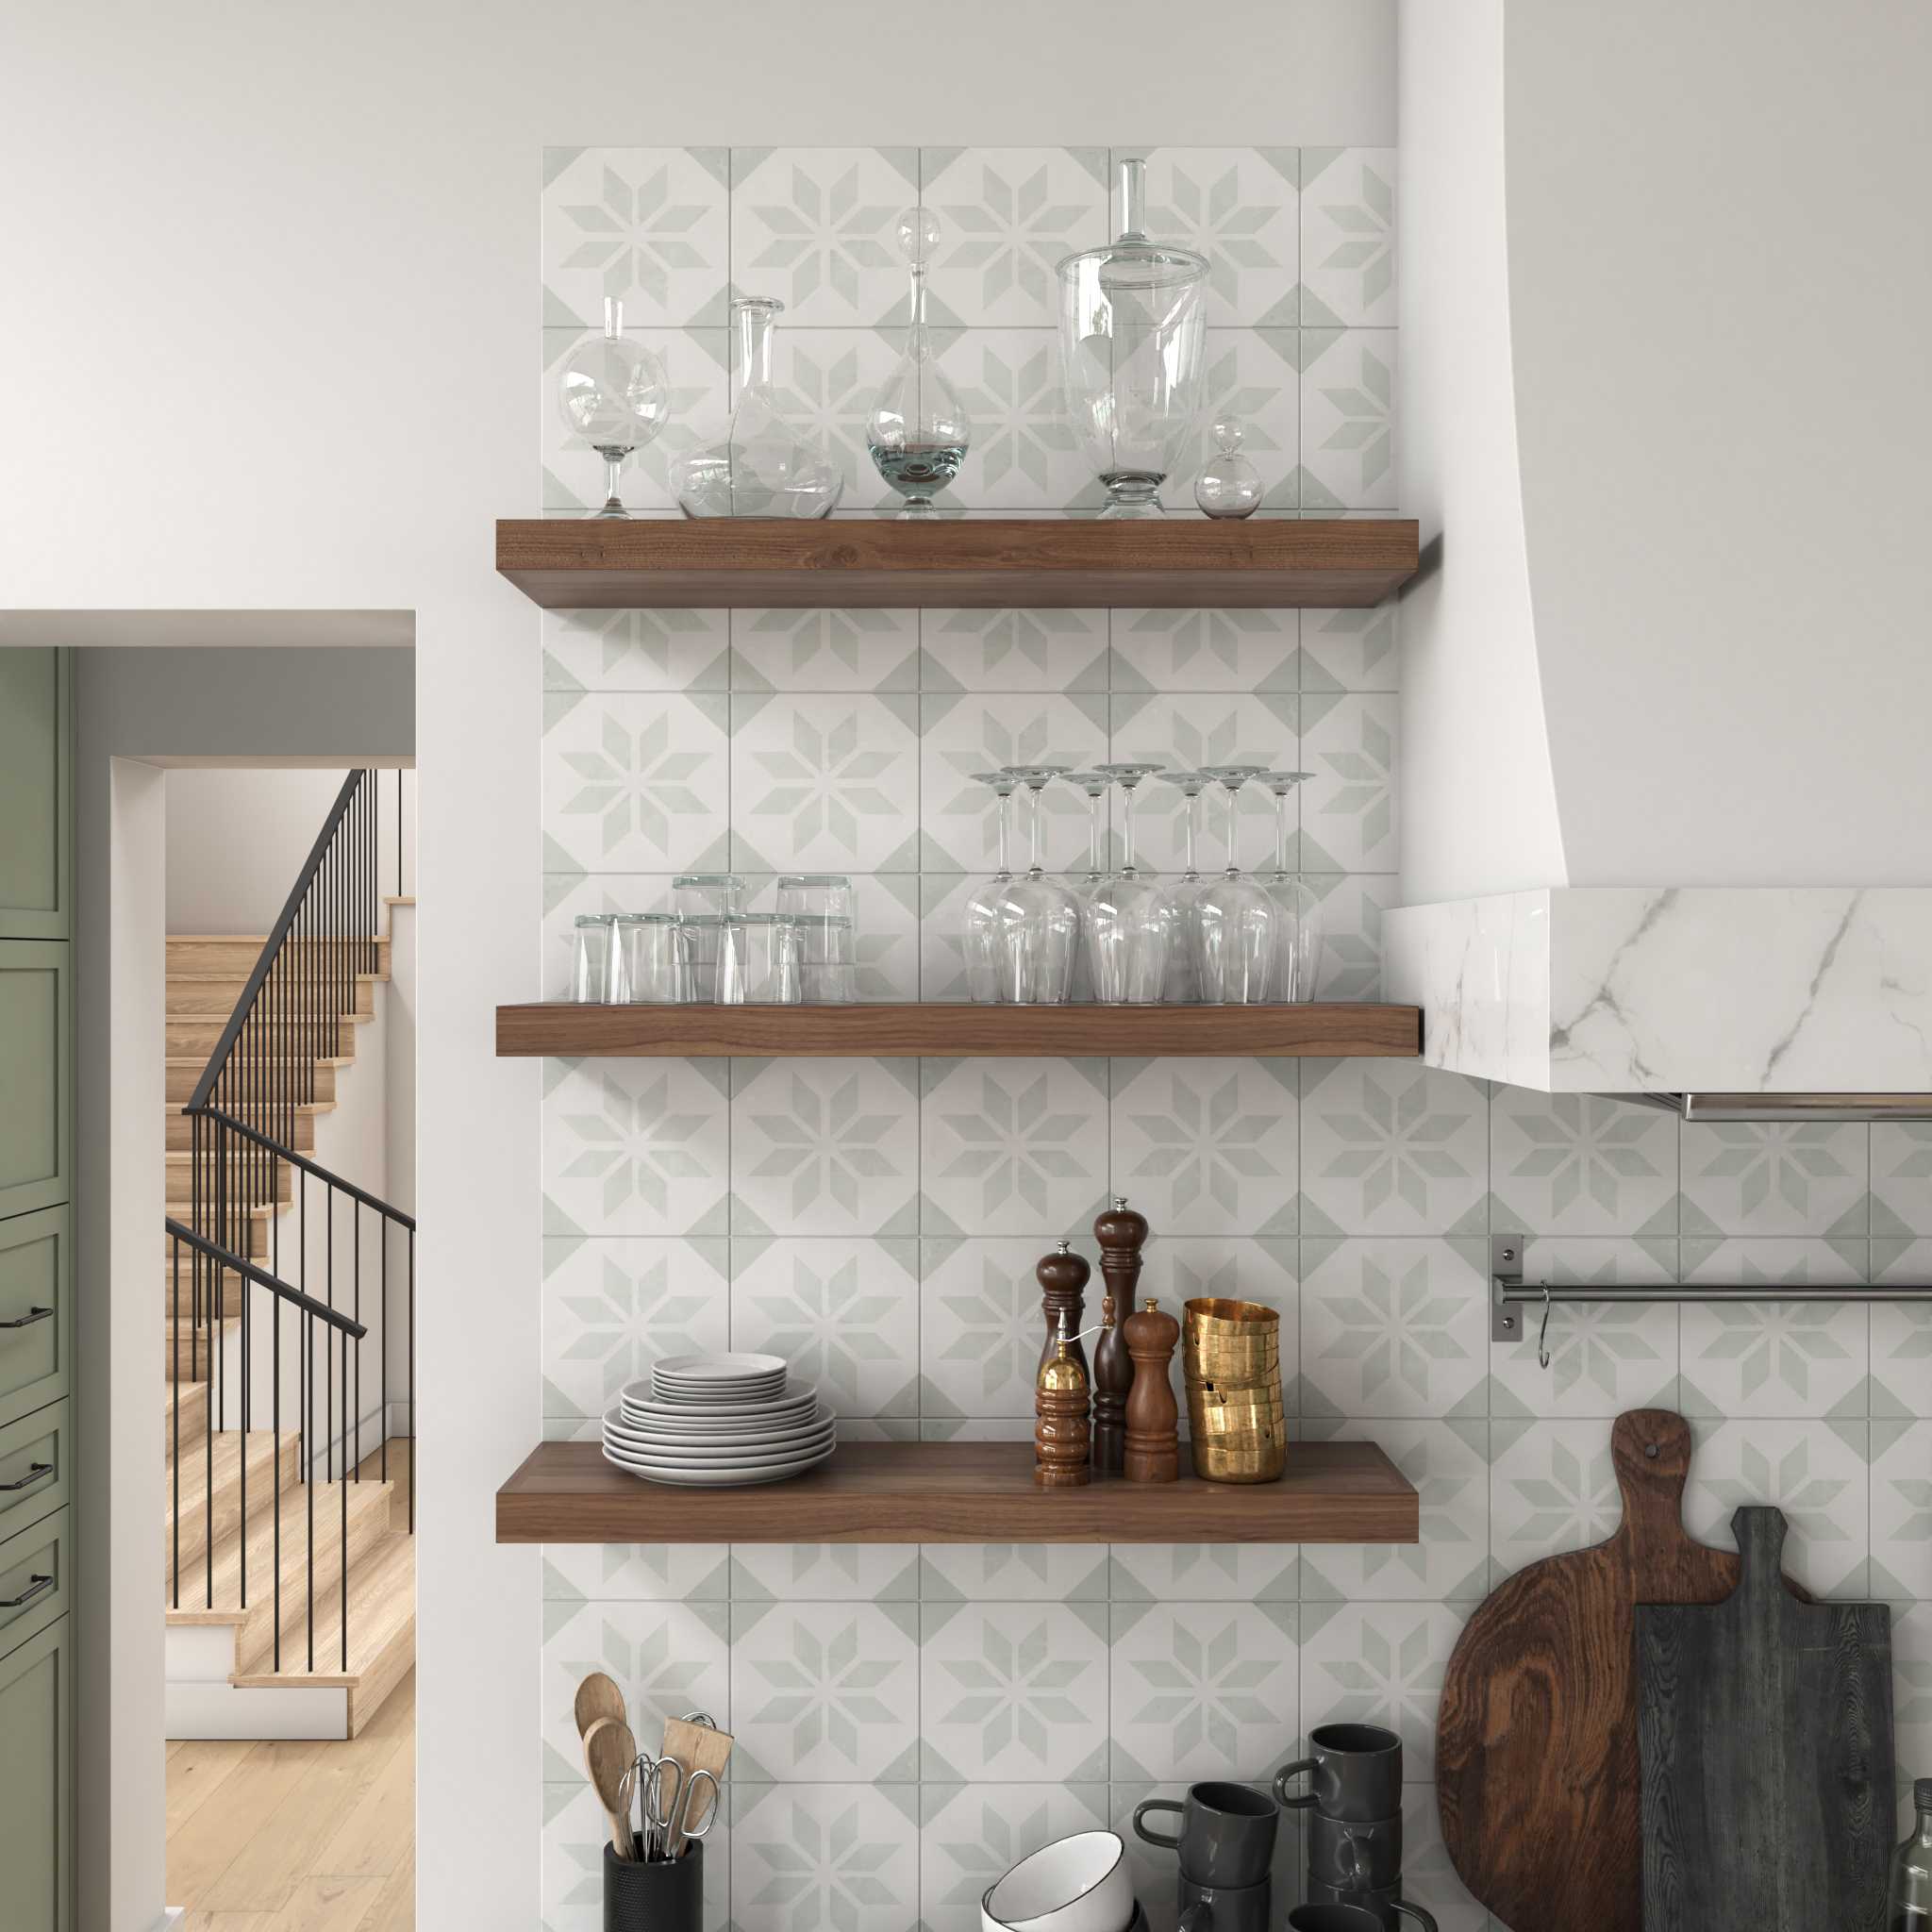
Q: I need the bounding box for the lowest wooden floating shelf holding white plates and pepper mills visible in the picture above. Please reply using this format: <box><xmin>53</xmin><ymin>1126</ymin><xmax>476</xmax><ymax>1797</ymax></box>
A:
<box><xmin>496</xmin><ymin>1441</ymin><xmax>1420</xmax><ymax>1543</ymax></box>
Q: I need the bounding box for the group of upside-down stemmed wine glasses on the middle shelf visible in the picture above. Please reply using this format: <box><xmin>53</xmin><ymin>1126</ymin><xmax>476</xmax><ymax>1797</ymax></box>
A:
<box><xmin>964</xmin><ymin>763</ymin><xmax>1322</xmax><ymax>1007</ymax></box>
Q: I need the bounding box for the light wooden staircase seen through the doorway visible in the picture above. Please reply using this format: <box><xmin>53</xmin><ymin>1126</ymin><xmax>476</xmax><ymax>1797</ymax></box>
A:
<box><xmin>162</xmin><ymin>900</ymin><xmax>415</xmax><ymax>1739</ymax></box>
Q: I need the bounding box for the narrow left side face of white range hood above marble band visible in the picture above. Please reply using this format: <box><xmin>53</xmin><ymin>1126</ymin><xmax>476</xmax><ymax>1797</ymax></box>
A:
<box><xmin>1397</xmin><ymin>0</ymin><xmax>1563</xmax><ymax>904</ymax></box>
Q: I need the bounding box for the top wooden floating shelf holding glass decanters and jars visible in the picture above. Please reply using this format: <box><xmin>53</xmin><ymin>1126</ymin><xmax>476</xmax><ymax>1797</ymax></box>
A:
<box><xmin>496</xmin><ymin>516</ymin><xmax>1418</xmax><ymax>610</ymax></box>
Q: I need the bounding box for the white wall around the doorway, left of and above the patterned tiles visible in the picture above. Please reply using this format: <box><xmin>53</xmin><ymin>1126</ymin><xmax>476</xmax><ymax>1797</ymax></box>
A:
<box><xmin>0</xmin><ymin>0</ymin><xmax>1395</xmax><ymax>1932</ymax></box>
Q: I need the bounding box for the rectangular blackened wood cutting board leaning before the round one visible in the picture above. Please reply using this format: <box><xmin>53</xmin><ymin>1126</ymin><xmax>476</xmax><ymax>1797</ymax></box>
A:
<box><xmin>1637</xmin><ymin>1508</ymin><xmax>1895</xmax><ymax>1932</ymax></box>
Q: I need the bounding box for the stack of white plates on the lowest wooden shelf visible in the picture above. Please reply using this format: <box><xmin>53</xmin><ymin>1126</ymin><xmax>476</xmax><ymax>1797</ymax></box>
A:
<box><xmin>605</xmin><ymin>1355</ymin><xmax>839</xmax><ymax>1490</ymax></box>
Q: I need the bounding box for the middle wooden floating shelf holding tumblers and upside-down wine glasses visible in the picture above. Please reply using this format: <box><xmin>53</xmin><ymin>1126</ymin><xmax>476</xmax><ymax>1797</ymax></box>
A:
<box><xmin>496</xmin><ymin>1001</ymin><xmax>1422</xmax><ymax>1060</ymax></box>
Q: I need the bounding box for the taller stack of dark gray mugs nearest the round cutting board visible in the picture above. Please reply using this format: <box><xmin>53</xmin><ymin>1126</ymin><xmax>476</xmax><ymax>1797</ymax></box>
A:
<box><xmin>1275</xmin><ymin>1724</ymin><xmax>1436</xmax><ymax>1932</ymax></box>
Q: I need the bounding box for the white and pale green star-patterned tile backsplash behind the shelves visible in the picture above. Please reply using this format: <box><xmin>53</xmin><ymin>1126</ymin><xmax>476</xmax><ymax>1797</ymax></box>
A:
<box><xmin>531</xmin><ymin>149</ymin><xmax>1932</xmax><ymax>1932</ymax></box>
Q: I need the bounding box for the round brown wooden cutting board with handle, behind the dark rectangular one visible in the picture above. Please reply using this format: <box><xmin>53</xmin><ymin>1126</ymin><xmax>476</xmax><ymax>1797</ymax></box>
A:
<box><xmin>1436</xmin><ymin>1408</ymin><xmax>1792</xmax><ymax>1932</ymax></box>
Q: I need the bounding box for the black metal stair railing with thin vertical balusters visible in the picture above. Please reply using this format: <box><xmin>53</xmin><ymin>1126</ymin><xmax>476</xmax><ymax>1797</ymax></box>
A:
<box><xmin>168</xmin><ymin>771</ymin><xmax>415</xmax><ymax>1674</ymax></box>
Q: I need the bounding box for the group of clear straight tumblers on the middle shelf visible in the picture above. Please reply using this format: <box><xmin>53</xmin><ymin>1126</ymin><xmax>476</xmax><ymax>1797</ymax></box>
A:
<box><xmin>570</xmin><ymin>872</ymin><xmax>858</xmax><ymax>1007</ymax></box>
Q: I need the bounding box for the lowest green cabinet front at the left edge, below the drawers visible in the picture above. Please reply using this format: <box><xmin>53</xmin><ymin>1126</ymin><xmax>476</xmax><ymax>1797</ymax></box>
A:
<box><xmin>0</xmin><ymin>1617</ymin><xmax>74</xmax><ymax>1932</ymax></box>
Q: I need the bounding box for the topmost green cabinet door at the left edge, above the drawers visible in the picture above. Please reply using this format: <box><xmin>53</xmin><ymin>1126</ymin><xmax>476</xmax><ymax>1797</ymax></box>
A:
<box><xmin>0</xmin><ymin>645</ymin><xmax>74</xmax><ymax>939</ymax></box>
